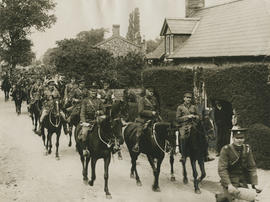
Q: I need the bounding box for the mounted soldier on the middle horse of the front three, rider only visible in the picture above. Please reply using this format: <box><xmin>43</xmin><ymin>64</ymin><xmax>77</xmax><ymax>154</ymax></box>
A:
<box><xmin>132</xmin><ymin>88</ymin><xmax>159</xmax><ymax>152</ymax></box>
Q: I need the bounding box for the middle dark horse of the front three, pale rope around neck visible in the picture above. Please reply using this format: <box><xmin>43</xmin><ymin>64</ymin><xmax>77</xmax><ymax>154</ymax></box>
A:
<box><xmin>124</xmin><ymin>122</ymin><xmax>175</xmax><ymax>192</ymax></box>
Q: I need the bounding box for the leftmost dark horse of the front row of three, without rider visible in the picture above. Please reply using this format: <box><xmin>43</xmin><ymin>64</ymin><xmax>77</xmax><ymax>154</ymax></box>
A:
<box><xmin>75</xmin><ymin>105</ymin><xmax>123</xmax><ymax>199</ymax></box>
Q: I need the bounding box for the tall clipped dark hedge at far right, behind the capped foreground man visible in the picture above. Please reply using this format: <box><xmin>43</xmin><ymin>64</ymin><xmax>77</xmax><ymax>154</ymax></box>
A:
<box><xmin>204</xmin><ymin>64</ymin><xmax>270</xmax><ymax>127</ymax></box>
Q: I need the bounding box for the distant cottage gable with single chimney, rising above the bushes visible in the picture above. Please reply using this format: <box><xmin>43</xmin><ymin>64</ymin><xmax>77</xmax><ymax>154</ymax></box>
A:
<box><xmin>95</xmin><ymin>25</ymin><xmax>145</xmax><ymax>57</ymax></box>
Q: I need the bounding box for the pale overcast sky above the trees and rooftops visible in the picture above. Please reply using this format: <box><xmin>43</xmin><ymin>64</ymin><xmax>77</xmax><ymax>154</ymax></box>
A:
<box><xmin>31</xmin><ymin>0</ymin><xmax>231</xmax><ymax>59</ymax></box>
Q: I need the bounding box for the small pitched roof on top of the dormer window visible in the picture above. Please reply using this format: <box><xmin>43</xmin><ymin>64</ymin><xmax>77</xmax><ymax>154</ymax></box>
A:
<box><xmin>160</xmin><ymin>18</ymin><xmax>199</xmax><ymax>36</ymax></box>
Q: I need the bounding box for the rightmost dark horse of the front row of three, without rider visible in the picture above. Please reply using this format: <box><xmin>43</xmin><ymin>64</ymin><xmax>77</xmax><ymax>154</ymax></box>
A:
<box><xmin>170</xmin><ymin>120</ymin><xmax>207</xmax><ymax>194</ymax></box>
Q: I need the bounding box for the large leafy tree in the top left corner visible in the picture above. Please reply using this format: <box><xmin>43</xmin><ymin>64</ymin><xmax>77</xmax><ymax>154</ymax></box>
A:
<box><xmin>0</xmin><ymin>0</ymin><xmax>56</xmax><ymax>69</ymax></box>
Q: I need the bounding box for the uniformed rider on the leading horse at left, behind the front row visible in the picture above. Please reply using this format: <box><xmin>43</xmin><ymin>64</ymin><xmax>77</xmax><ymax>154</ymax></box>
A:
<box><xmin>37</xmin><ymin>80</ymin><xmax>68</xmax><ymax>135</ymax></box>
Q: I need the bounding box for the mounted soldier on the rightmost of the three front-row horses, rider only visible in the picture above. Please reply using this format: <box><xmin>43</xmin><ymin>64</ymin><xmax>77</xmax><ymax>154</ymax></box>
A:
<box><xmin>176</xmin><ymin>92</ymin><xmax>199</xmax><ymax>161</ymax></box>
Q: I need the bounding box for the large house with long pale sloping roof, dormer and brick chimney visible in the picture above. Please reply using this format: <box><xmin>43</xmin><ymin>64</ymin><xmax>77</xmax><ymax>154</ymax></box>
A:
<box><xmin>146</xmin><ymin>0</ymin><xmax>270</xmax><ymax>67</ymax></box>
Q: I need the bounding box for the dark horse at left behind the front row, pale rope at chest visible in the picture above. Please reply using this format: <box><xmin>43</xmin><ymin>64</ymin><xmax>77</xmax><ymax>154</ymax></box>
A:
<box><xmin>41</xmin><ymin>101</ymin><xmax>63</xmax><ymax>160</ymax></box>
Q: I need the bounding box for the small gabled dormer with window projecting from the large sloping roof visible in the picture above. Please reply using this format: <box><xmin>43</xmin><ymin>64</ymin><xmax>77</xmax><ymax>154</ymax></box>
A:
<box><xmin>160</xmin><ymin>18</ymin><xmax>200</xmax><ymax>56</ymax></box>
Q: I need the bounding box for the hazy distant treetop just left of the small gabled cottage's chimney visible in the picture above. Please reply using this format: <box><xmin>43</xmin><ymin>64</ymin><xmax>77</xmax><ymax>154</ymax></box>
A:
<box><xmin>77</xmin><ymin>28</ymin><xmax>108</xmax><ymax>46</ymax></box>
